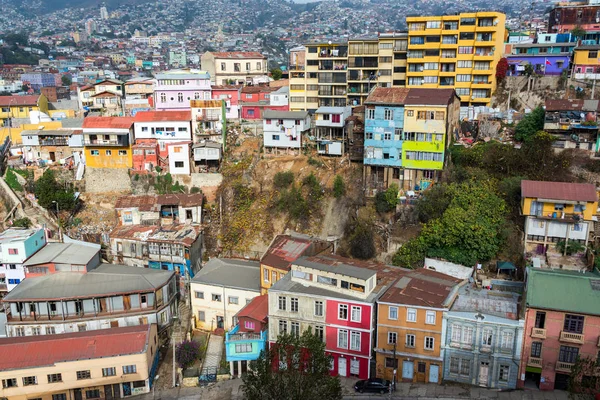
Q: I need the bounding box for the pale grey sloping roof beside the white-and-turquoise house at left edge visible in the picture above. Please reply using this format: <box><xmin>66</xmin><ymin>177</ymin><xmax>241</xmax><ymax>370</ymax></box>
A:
<box><xmin>24</xmin><ymin>242</ymin><xmax>100</xmax><ymax>266</ymax></box>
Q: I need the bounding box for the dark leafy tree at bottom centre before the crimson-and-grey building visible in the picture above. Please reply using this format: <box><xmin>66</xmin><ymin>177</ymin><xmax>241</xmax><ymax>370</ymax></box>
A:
<box><xmin>242</xmin><ymin>328</ymin><xmax>342</xmax><ymax>400</ymax></box>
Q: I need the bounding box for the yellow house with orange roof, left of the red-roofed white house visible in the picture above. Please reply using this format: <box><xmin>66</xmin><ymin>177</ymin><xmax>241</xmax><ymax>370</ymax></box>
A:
<box><xmin>83</xmin><ymin>117</ymin><xmax>133</xmax><ymax>168</ymax></box>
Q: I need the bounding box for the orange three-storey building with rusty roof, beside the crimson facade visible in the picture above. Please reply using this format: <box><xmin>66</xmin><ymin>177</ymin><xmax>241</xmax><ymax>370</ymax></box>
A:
<box><xmin>375</xmin><ymin>268</ymin><xmax>462</xmax><ymax>383</ymax></box>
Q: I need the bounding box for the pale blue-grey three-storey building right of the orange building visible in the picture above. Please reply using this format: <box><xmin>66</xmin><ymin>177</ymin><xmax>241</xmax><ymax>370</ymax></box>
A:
<box><xmin>442</xmin><ymin>280</ymin><xmax>524</xmax><ymax>389</ymax></box>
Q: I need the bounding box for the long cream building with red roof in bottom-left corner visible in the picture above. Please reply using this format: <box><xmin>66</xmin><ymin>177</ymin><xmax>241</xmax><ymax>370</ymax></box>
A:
<box><xmin>0</xmin><ymin>324</ymin><xmax>159</xmax><ymax>400</ymax></box>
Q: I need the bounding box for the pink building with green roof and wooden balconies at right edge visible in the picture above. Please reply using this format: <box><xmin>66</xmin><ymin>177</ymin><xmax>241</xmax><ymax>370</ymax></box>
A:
<box><xmin>517</xmin><ymin>268</ymin><xmax>600</xmax><ymax>390</ymax></box>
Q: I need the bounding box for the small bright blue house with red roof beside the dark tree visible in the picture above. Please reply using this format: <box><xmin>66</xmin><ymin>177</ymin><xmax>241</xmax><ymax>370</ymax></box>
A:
<box><xmin>225</xmin><ymin>294</ymin><xmax>269</xmax><ymax>376</ymax></box>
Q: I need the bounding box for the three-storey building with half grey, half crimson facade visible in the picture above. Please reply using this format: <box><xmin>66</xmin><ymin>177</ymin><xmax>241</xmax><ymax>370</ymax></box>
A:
<box><xmin>268</xmin><ymin>254</ymin><xmax>397</xmax><ymax>379</ymax></box>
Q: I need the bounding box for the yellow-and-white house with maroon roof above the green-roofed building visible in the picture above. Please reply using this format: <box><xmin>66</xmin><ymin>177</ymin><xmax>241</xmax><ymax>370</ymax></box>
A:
<box><xmin>521</xmin><ymin>180</ymin><xmax>598</xmax><ymax>253</ymax></box>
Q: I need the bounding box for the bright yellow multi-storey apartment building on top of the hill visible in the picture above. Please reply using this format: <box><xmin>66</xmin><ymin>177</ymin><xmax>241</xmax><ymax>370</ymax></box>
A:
<box><xmin>406</xmin><ymin>11</ymin><xmax>506</xmax><ymax>106</ymax></box>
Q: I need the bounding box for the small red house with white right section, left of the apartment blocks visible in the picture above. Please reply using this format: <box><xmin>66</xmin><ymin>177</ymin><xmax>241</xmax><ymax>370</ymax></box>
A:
<box><xmin>240</xmin><ymin>86</ymin><xmax>290</xmax><ymax>120</ymax></box>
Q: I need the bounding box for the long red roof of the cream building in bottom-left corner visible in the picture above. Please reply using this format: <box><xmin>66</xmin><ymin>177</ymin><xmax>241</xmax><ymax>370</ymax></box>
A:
<box><xmin>0</xmin><ymin>325</ymin><xmax>150</xmax><ymax>371</ymax></box>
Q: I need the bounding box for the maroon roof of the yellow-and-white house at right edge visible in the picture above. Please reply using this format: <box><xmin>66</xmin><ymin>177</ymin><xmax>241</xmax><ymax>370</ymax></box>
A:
<box><xmin>521</xmin><ymin>180</ymin><xmax>598</xmax><ymax>202</ymax></box>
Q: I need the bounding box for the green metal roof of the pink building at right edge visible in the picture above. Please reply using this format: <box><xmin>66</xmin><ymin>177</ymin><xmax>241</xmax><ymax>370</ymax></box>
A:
<box><xmin>527</xmin><ymin>268</ymin><xmax>600</xmax><ymax>315</ymax></box>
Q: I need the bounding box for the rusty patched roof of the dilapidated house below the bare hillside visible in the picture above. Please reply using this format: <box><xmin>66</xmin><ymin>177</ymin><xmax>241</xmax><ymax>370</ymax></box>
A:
<box><xmin>110</xmin><ymin>224</ymin><xmax>200</xmax><ymax>246</ymax></box>
